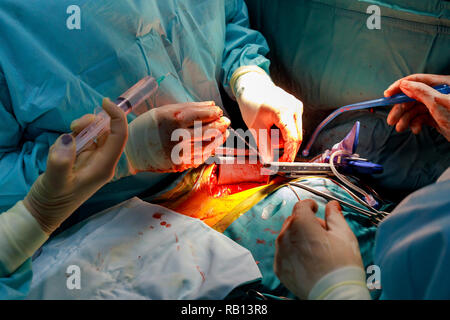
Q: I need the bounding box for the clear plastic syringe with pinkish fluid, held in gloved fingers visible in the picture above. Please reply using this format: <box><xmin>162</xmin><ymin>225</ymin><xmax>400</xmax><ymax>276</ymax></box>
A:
<box><xmin>75</xmin><ymin>76</ymin><xmax>165</xmax><ymax>155</ymax></box>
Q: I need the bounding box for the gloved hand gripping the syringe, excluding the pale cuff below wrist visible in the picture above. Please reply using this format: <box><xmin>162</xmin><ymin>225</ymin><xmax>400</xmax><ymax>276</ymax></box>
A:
<box><xmin>24</xmin><ymin>99</ymin><xmax>127</xmax><ymax>234</ymax></box>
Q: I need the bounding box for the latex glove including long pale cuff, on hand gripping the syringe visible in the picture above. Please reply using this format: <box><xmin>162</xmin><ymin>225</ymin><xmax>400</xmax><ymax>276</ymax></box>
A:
<box><xmin>0</xmin><ymin>99</ymin><xmax>127</xmax><ymax>277</ymax></box>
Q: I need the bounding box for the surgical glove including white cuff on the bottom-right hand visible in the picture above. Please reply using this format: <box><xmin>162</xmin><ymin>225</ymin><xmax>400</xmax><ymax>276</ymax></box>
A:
<box><xmin>274</xmin><ymin>199</ymin><xmax>370</xmax><ymax>299</ymax></box>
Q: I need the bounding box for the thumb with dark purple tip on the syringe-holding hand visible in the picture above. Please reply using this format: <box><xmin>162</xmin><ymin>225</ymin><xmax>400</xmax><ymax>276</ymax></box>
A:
<box><xmin>44</xmin><ymin>134</ymin><xmax>76</xmax><ymax>188</ymax></box>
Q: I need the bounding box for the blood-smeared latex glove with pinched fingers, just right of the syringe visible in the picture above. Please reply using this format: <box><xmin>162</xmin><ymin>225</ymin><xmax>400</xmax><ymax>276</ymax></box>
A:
<box><xmin>125</xmin><ymin>102</ymin><xmax>230</xmax><ymax>173</ymax></box>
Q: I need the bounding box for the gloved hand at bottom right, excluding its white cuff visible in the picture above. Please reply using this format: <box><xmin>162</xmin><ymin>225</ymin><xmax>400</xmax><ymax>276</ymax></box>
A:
<box><xmin>274</xmin><ymin>199</ymin><xmax>364</xmax><ymax>299</ymax></box>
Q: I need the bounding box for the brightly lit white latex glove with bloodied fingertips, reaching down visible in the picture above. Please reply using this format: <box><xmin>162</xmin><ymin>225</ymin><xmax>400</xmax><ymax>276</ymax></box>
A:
<box><xmin>230</xmin><ymin>66</ymin><xmax>303</xmax><ymax>162</ymax></box>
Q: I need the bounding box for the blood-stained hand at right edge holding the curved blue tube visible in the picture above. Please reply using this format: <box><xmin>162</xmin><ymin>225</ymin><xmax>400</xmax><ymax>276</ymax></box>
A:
<box><xmin>384</xmin><ymin>74</ymin><xmax>450</xmax><ymax>141</ymax></box>
